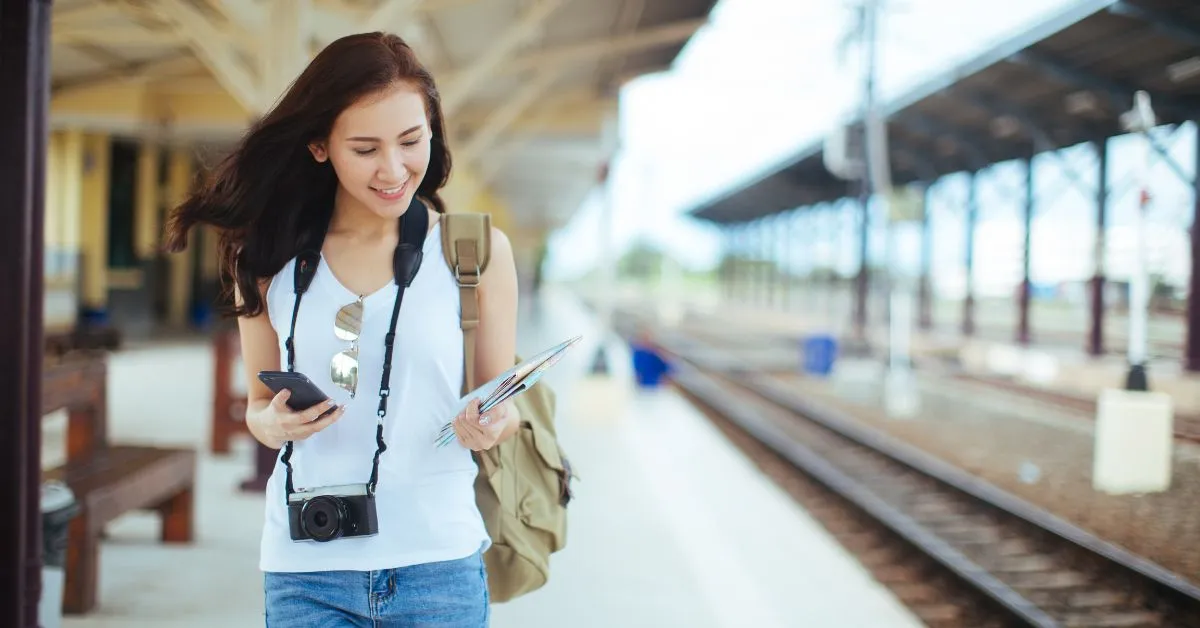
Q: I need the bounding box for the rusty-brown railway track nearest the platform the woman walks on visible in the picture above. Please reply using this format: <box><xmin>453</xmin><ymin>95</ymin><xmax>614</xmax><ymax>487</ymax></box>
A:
<box><xmin>660</xmin><ymin>336</ymin><xmax>1200</xmax><ymax>628</ymax></box>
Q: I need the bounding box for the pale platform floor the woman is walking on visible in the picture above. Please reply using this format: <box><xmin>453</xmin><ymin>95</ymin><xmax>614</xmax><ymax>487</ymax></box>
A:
<box><xmin>44</xmin><ymin>292</ymin><xmax>919</xmax><ymax>628</ymax></box>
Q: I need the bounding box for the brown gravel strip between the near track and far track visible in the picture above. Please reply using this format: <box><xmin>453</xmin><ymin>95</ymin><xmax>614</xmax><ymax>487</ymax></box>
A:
<box><xmin>635</xmin><ymin>300</ymin><xmax>1200</xmax><ymax>585</ymax></box>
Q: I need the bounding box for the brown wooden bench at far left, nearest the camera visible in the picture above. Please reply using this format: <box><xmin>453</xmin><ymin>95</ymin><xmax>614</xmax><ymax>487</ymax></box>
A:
<box><xmin>42</xmin><ymin>352</ymin><xmax>196</xmax><ymax>614</ymax></box>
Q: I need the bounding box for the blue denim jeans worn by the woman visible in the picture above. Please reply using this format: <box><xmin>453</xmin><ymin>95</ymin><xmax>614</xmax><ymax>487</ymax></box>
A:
<box><xmin>263</xmin><ymin>552</ymin><xmax>490</xmax><ymax>628</ymax></box>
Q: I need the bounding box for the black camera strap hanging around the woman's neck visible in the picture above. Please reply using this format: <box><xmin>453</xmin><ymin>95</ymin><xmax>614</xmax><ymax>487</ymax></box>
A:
<box><xmin>280</xmin><ymin>196</ymin><xmax>430</xmax><ymax>504</ymax></box>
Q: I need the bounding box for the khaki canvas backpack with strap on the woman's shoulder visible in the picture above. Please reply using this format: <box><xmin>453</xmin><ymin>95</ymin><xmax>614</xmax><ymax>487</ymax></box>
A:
<box><xmin>442</xmin><ymin>214</ymin><xmax>571</xmax><ymax>602</ymax></box>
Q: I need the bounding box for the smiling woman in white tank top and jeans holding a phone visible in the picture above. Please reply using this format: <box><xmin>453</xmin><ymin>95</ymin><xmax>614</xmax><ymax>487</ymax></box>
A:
<box><xmin>168</xmin><ymin>32</ymin><xmax>520</xmax><ymax>627</ymax></box>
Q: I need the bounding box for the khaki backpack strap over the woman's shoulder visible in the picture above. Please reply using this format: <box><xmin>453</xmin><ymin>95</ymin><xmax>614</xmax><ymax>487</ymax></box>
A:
<box><xmin>442</xmin><ymin>213</ymin><xmax>492</xmax><ymax>394</ymax></box>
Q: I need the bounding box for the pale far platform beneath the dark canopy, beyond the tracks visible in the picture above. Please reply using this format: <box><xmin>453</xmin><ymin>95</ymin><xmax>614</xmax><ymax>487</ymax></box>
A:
<box><xmin>609</xmin><ymin>291</ymin><xmax>1200</xmax><ymax>417</ymax></box>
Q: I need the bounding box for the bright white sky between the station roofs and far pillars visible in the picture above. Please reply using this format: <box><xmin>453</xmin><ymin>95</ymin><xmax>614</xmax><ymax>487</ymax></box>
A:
<box><xmin>547</xmin><ymin>0</ymin><xmax>1195</xmax><ymax>292</ymax></box>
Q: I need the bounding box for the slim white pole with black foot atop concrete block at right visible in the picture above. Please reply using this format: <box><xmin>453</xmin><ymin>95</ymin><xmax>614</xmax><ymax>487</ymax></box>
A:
<box><xmin>1122</xmin><ymin>91</ymin><xmax>1156</xmax><ymax>390</ymax></box>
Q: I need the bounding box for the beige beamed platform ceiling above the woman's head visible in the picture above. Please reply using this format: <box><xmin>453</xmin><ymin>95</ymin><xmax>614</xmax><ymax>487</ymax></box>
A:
<box><xmin>52</xmin><ymin>0</ymin><xmax>715</xmax><ymax>234</ymax></box>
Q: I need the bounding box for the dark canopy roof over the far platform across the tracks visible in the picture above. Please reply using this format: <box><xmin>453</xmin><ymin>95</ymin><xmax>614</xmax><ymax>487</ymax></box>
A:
<box><xmin>690</xmin><ymin>0</ymin><xmax>1200</xmax><ymax>223</ymax></box>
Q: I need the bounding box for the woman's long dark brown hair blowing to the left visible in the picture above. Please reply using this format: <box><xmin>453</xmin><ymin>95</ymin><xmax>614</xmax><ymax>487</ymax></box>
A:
<box><xmin>166</xmin><ymin>32</ymin><xmax>450</xmax><ymax>316</ymax></box>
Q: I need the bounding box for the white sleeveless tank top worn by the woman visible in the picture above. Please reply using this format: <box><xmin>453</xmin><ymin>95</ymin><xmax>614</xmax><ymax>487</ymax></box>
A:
<box><xmin>259</xmin><ymin>223</ymin><xmax>490</xmax><ymax>572</ymax></box>
